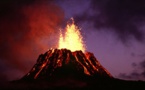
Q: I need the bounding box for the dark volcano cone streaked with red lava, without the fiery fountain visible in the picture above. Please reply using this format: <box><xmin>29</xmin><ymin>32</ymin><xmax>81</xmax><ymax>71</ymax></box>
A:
<box><xmin>22</xmin><ymin>49</ymin><xmax>112</xmax><ymax>80</ymax></box>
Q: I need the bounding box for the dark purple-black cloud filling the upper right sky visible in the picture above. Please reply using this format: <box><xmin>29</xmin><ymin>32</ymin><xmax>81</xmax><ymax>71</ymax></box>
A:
<box><xmin>75</xmin><ymin>0</ymin><xmax>145</xmax><ymax>43</ymax></box>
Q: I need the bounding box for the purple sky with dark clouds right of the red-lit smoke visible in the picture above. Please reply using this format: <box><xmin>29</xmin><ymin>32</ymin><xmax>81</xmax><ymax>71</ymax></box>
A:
<box><xmin>58</xmin><ymin>0</ymin><xmax>145</xmax><ymax>80</ymax></box>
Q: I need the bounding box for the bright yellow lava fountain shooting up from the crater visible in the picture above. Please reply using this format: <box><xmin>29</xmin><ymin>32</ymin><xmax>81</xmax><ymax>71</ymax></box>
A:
<box><xmin>58</xmin><ymin>18</ymin><xmax>85</xmax><ymax>52</ymax></box>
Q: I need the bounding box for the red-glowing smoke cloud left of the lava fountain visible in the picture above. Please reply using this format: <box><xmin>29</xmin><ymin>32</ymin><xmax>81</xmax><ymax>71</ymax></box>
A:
<box><xmin>0</xmin><ymin>0</ymin><xmax>64</xmax><ymax>78</ymax></box>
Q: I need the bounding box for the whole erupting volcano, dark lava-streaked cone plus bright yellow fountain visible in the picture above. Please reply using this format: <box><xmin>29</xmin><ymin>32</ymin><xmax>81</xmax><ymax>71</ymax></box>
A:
<box><xmin>22</xmin><ymin>18</ymin><xmax>112</xmax><ymax>80</ymax></box>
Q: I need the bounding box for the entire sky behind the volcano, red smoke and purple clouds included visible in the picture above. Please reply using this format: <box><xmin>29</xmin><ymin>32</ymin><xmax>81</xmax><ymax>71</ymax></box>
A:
<box><xmin>0</xmin><ymin>0</ymin><xmax>145</xmax><ymax>81</ymax></box>
